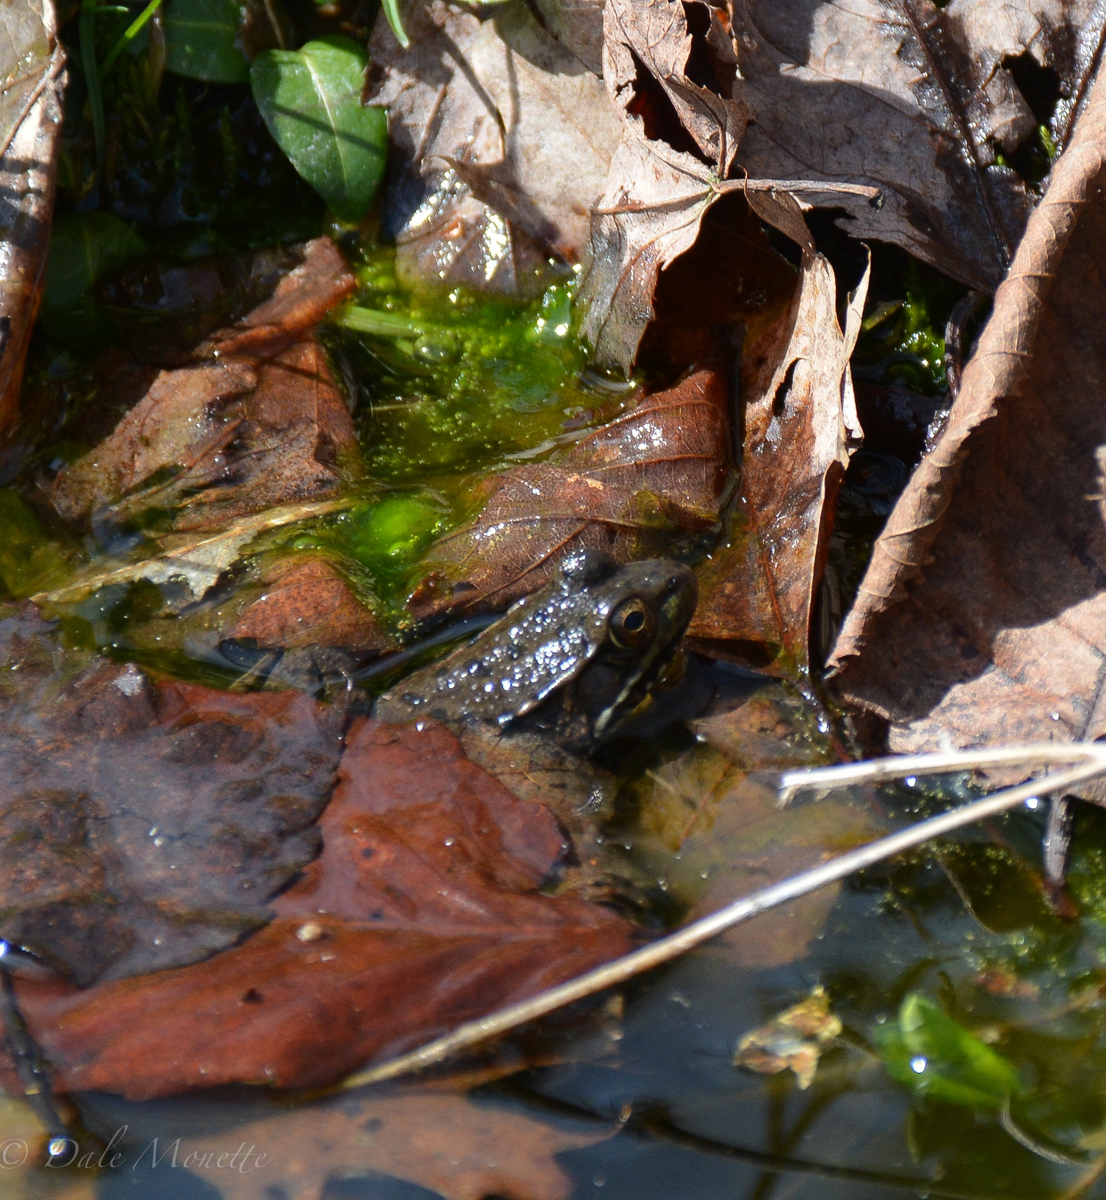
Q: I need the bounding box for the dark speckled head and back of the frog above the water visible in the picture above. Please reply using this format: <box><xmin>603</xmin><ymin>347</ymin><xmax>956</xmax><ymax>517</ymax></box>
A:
<box><xmin>375</xmin><ymin>550</ymin><xmax>698</xmax><ymax>752</ymax></box>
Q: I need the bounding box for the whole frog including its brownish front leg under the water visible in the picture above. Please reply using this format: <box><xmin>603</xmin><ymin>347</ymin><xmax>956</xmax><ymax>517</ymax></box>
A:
<box><xmin>373</xmin><ymin>550</ymin><xmax>698</xmax><ymax>910</ymax></box>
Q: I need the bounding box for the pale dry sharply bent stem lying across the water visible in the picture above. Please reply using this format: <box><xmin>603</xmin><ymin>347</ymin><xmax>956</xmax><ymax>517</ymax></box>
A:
<box><xmin>341</xmin><ymin>743</ymin><xmax>1106</xmax><ymax>1088</ymax></box>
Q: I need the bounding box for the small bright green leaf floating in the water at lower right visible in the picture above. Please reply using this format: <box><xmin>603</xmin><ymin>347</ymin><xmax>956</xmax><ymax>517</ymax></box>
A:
<box><xmin>877</xmin><ymin>992</ymin><xmax>1018</xmax><ymax>1109</ymax></box>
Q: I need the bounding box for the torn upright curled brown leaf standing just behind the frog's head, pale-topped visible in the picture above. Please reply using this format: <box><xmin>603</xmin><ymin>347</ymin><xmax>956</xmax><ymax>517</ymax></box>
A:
<box><xmin>690</xmin><ymin>236</ymin><xmax>867</xmax><ymax>674</ymax></box>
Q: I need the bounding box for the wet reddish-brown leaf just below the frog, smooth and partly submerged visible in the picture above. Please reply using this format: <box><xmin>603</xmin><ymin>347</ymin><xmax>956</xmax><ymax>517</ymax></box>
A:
<box><xmin>8</xmin><ymin>715</ymin><xmax>630</xmax><ymax>1098</ymax></box>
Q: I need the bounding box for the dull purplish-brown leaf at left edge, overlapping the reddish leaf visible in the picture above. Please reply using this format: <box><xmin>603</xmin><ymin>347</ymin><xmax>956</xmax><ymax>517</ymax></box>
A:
<box><xmin>0</xmin><ymin>606</ymin><xmax>344</xmax><ymax>984</ymax></box>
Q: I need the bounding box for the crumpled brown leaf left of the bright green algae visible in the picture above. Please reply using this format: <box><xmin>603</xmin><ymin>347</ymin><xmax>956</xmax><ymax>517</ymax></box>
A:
<box><xmin>53</xmin><ymin>238</ymin><xmax>356</xmax><ymax>530</ymax></box>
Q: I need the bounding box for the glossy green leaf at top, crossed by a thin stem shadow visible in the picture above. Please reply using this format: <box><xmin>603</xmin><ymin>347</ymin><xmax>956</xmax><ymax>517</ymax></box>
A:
<box><xmin>250</xmin><ymin>37</ymin><xmax>387</xmax><ymax>222</ymax></box>
